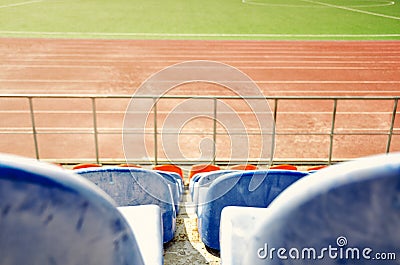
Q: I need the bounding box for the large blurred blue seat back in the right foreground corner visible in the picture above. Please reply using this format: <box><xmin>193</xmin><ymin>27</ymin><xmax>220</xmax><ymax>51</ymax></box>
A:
<box><xmin>239</xmin><ymin>153</ymin><xmax>400</xmax><ymax>265</ymax></box>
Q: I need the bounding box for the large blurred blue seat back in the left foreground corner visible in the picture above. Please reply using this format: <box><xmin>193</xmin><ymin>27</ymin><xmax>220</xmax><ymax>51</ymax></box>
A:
<box><xmin>0</xmin><ymin>154</ymin><xmax>144</xmax><ymax>265</ymax></box>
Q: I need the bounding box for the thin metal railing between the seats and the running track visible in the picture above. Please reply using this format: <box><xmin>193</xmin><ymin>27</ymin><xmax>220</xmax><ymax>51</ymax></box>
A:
<box><xmin>0</xmin><ymin>94</ymin><xmax>400</xmax><ymax>164</ymax></box>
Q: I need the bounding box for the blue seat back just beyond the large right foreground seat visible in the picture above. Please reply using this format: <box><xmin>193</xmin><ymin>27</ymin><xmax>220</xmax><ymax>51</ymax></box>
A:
<box><xmin>198</xmin><ymin>170</ymin><xmax>307</xmax><ymax>250</ymax></box>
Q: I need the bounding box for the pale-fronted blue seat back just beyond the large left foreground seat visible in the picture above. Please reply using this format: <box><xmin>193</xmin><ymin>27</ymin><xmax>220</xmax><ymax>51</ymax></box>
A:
<box><xmin>75</xmin><ymin>167</ymin><xmax>176</xmax><ymax>243</ymax></box>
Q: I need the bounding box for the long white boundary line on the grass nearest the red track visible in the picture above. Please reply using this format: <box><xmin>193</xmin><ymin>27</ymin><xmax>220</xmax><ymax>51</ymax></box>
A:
<box><xmin>0</xmin><ymin>30</ymin><xmax>400</xmax><ymax>38</ymax></box>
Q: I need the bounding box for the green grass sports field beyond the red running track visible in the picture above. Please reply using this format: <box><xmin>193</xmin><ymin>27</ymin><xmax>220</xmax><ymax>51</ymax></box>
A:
<box><xmin>0</xmin><ymin>0</ymin><xmax>400</xmax><ymax>40</ymax></box>
